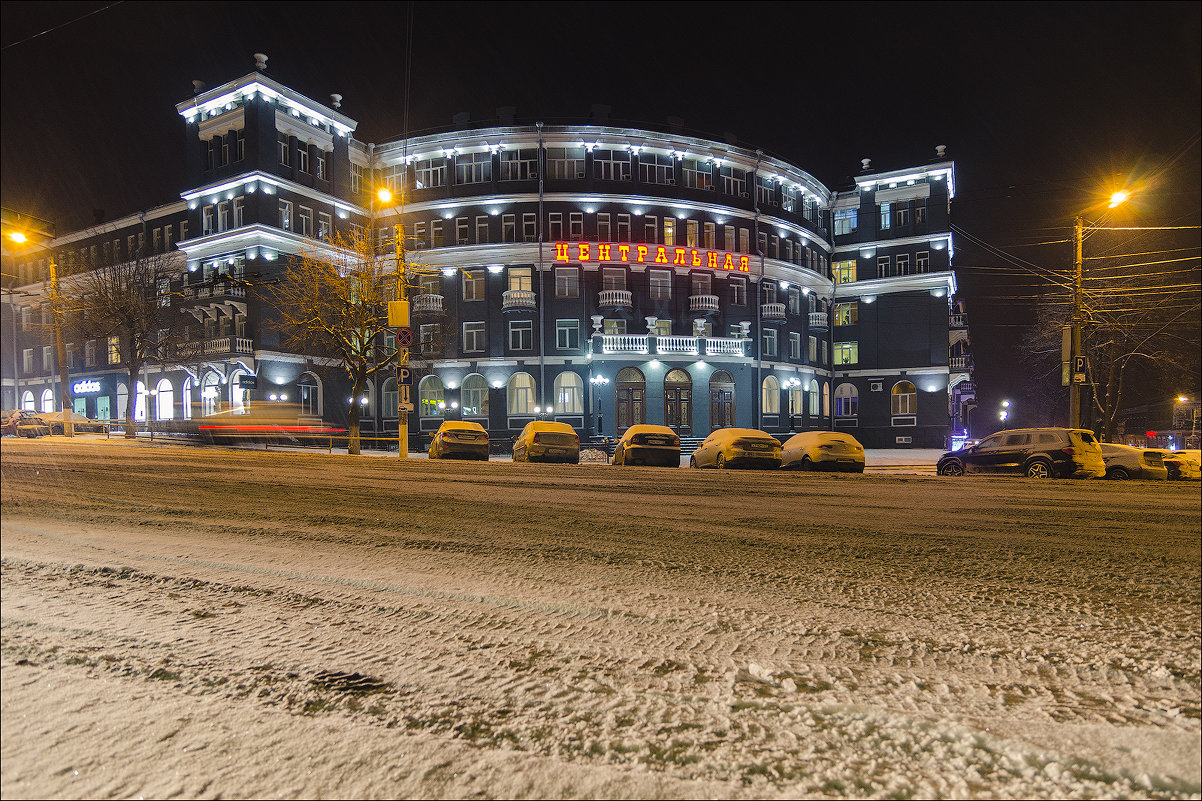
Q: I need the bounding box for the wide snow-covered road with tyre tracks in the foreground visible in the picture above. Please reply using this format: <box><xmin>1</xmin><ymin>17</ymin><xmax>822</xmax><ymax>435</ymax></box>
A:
<box><xmin>0</xmin><ymin>438</ymin><xmax>1202</xmax><ymax>799</ymax></box>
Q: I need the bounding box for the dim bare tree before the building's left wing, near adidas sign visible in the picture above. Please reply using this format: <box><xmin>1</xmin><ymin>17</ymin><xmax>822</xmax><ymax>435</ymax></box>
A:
<box><xmin>60</xmin><ymin>246</ymin><xmax>184</xmax><ymax>439</ymax></box>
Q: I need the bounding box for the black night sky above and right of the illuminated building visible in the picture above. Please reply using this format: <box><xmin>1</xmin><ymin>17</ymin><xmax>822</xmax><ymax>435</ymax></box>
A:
<box><xmin>0</xmin><ymin>2</ymin><xmax>1202</xmax><ymax>423</ymax></box>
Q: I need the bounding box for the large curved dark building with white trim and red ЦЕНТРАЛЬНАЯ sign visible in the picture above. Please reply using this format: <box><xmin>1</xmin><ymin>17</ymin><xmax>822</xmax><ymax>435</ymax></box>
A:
<box><xmin>2</xmin><ymin>57</ymin><xmax>971</xmax><ymax>449</ymax></box>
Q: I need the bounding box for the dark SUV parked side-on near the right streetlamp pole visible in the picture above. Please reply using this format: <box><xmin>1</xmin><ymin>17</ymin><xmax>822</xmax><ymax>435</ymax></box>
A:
<box><xmin>935</xmin><ymin>428</ymin><xmax>1106</xmax><ymax>479</ymax></box>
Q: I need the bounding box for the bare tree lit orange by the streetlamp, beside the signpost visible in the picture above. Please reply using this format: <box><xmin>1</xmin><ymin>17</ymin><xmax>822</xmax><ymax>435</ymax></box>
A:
<box><xmin>270</xmin><ymin>229</ymin><xmax>413</xmax><ymax>453</ymax></box>
